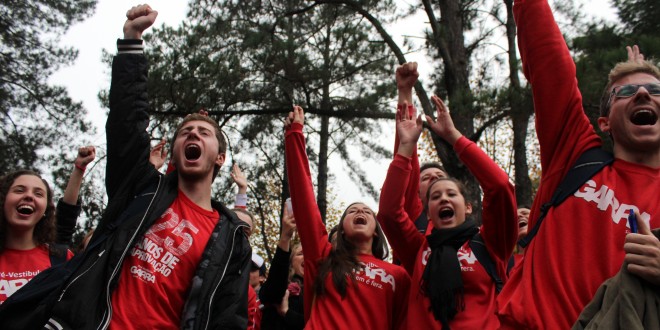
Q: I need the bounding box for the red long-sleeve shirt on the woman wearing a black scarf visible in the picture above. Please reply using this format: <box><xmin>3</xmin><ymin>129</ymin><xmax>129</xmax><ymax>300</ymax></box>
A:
<box><xmin>378</xmin><ymin>137</ymin><xmax>518</xmax><ymax>329</ymax></box>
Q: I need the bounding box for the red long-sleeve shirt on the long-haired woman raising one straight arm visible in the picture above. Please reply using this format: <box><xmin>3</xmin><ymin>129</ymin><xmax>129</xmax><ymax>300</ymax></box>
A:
<box><xmin>285</xmin><ymin>123</ymin><xmax>410</xmax><ymax>329</ymax></box>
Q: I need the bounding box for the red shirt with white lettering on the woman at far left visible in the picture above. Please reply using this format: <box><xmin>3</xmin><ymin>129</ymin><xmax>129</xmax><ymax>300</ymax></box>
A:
<box><xmin>0</xmin><ymin>244</ymin><xmax>73</xmax><ymax>304</ymax></box>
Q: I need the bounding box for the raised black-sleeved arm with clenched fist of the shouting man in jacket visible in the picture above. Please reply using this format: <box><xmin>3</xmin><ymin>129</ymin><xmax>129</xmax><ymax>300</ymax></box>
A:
<box><xmin>106</xmin><ymin>5</ymin><xmax>158</xmax><ymax>199</ymax></box>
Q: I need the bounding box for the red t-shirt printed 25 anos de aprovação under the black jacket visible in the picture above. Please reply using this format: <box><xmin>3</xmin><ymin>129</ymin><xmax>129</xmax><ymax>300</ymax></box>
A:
<box><xmin>110</xmin><ymin>191</ymin><xmax>220</xmax><ymax>330</ymax></box>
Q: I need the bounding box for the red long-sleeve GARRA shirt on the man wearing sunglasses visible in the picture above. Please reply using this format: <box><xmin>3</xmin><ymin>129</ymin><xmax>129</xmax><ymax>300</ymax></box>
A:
<box><xmin>497</xmin><ymin>0</ymin><xmax>660</xmax><ymax>329</ymax></box>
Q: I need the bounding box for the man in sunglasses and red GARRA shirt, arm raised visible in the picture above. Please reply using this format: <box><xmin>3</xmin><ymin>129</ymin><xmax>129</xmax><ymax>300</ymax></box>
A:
<box><xmin>497</xmin><ymin>0</ymin><xmax>660</xmax><ymax>329</ymax></box>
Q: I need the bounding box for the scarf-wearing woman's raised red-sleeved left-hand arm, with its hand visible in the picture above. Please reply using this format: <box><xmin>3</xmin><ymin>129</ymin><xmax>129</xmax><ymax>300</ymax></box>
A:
<box><xmin>377</xmin><ymin>108</ymin><xmax>424</xmax><ymax>274</ymax></box>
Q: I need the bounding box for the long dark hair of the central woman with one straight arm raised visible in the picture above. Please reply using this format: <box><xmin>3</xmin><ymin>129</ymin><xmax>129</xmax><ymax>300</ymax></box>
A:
<box><xmin>314</xmin><ymin>203</ymin><xmax>389</xmax><ymax>298</ymax></box>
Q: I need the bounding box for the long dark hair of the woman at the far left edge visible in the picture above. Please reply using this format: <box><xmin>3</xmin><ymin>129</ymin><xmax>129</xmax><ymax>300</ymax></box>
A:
<box><xmin>0</xmin><ymin>170</ymin><xmax>57</xmax><ymax>252</ymax></box>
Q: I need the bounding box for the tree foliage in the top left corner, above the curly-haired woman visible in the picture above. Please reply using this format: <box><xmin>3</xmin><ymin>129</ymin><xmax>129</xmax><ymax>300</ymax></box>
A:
<box><xmin>0</xmin><ymin>0</ymin><xmax>96</xmax><ymax>177</ymax></box>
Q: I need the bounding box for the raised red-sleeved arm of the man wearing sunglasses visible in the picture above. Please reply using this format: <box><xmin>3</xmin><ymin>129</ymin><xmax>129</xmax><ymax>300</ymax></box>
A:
<box><xmin>514</xmin><ymin>0</ymin><xmax>600</xmax><ymax>173</ymax></box>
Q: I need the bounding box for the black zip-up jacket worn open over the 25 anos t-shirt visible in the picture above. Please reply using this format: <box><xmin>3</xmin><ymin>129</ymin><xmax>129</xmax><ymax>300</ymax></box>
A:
<box><xmin>42</xmin><ymin>47</ymin><xmax>251</xmax><ymax>329</ymax></box>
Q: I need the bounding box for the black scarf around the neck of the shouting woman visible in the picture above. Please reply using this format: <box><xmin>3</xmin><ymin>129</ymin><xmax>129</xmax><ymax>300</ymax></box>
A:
<box><xmin>422</xmin><ymin>220</ymin><xmax>479</xmax><ymax>329</ymax></box>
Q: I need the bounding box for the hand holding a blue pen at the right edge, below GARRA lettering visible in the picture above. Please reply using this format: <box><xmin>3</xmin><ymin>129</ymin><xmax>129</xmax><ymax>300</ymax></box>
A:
<box><xmin>623</xmin><ymin>212</ymin><xmax>660</xmax><ymax>285</ymax></box>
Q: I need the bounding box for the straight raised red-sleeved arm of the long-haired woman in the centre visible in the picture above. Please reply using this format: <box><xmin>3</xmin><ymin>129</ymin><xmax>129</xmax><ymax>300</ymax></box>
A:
<box><xmin>285</xmin><ymin>106</ymin><xmax>331</xmax><ymax>266</ymax></box>
